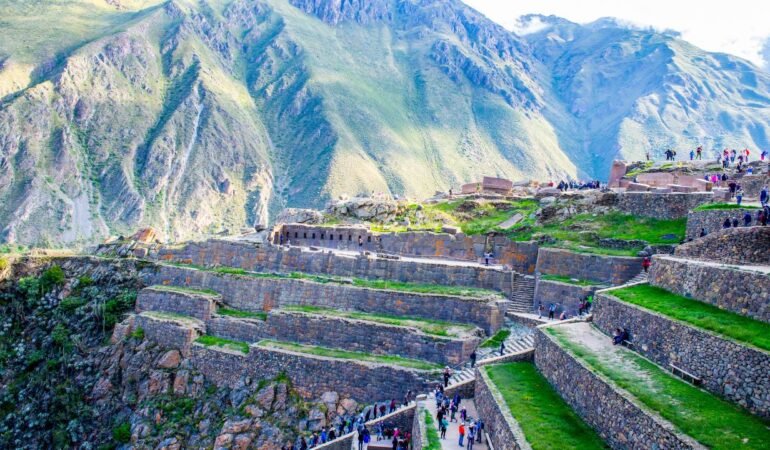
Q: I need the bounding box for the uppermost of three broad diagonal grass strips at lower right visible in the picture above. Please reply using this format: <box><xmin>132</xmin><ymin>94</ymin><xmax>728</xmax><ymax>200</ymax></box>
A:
<box><xmin>609</xmin><ymin>284</ymin><xmax>770</xmax><ymax>351</ymax></box>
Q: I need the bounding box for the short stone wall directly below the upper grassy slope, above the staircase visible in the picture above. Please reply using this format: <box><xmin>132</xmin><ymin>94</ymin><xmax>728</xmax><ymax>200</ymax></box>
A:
<box><xmin>537</xmin><ymin>248</ymin><xmax>642</xmax><ymax>286</ymax></box>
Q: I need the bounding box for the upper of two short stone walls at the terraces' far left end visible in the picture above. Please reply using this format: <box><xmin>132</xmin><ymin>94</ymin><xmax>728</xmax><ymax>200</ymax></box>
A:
<box><xmin>136</xmin><ymin>287</ymin><xmax>222</xmax><ymax>321</ymax></box>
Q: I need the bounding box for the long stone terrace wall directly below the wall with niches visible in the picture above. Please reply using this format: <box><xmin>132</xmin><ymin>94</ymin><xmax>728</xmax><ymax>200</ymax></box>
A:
<box><xmin>150</xmin><ymin>240</ymin><xmax>513</xmax><ymax>295</ymax></box>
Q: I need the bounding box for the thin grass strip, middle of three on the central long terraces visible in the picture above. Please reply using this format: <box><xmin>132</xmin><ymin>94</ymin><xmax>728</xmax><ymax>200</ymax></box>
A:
<box><xmin>282</xmin><ymin>305</ymin><xmax>475</xmax><ymax>336</ymax></box>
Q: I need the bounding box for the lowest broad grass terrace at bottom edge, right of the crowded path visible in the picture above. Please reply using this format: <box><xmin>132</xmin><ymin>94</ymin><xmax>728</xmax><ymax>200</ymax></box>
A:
<box><xmin>482</xmin><ymin>362</ymin><xmax>607</xmax><ymax>450</ymax></box>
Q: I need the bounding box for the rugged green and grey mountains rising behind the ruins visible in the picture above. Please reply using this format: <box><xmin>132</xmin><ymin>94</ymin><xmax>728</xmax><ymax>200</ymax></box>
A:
<box><xmin>0</xmin><ymin>0</ymin><xmax>770</xmax><ymax>245</ymax></box>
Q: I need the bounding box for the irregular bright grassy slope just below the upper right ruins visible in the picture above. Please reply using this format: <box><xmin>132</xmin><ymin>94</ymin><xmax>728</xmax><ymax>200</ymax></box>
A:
<box><xmin>505</xmin><ymin>212</ymin><xmax>687</xmax><ymax>256</ymax></box>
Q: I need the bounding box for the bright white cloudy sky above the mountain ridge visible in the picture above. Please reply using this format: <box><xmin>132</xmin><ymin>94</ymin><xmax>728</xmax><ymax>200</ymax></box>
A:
<box><xmin>463</xmin><ymin>0</ymin><xmax>770</xmax><ymax>69</ymax></box>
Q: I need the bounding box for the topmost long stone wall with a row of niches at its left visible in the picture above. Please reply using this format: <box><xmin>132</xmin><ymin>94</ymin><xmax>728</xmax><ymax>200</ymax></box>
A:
<box><xmin>273</xmin><ymin>224</ymin><xmax>538</xmax><ymax>273</ymax></box>
